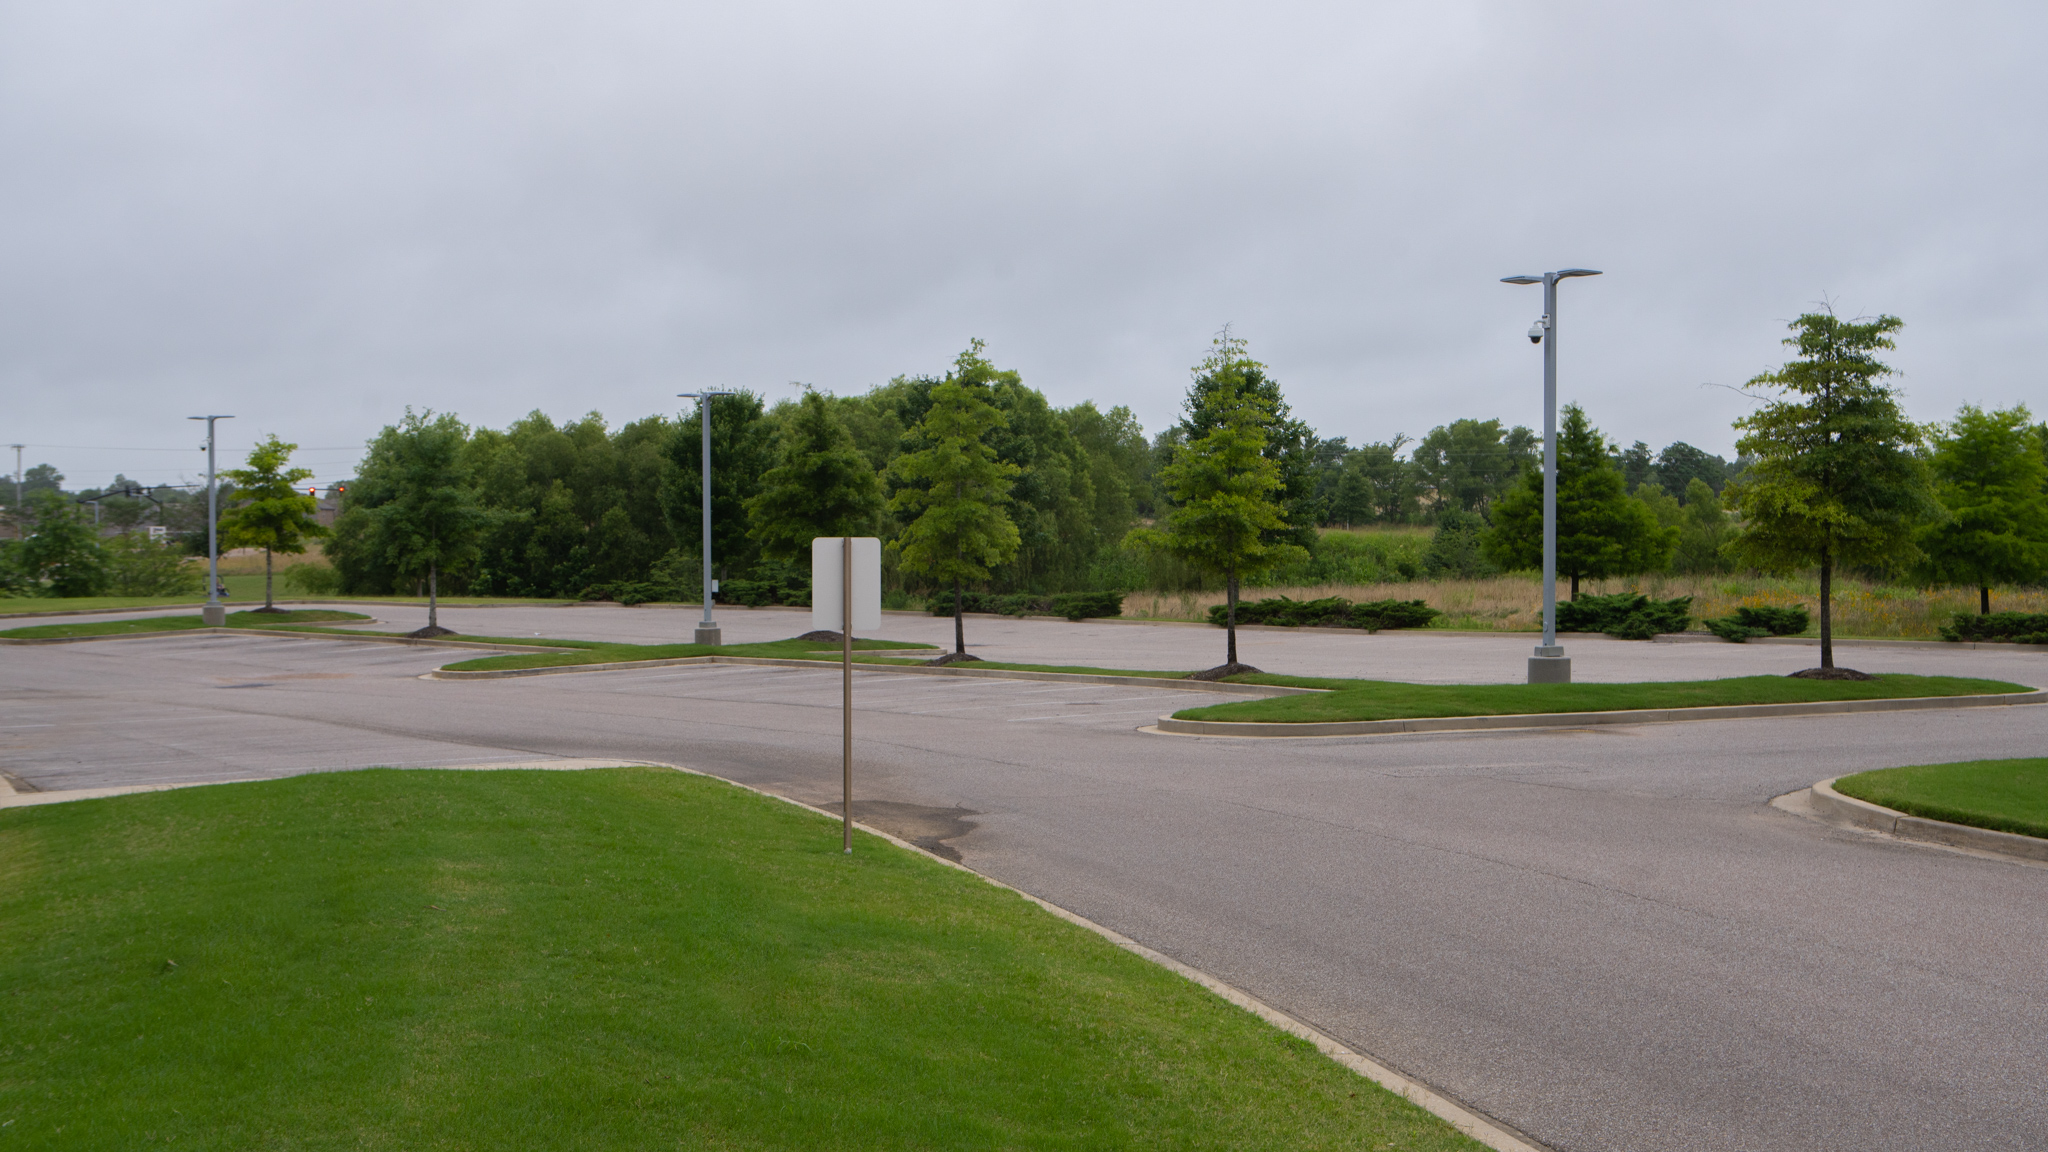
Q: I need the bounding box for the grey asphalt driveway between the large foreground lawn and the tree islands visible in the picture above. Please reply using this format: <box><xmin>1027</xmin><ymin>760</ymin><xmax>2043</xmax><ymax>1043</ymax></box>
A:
<box><xmin>0</xmin><ymin>623</ymin><xmax>2048</xmax><ymax>1150</ymax></box>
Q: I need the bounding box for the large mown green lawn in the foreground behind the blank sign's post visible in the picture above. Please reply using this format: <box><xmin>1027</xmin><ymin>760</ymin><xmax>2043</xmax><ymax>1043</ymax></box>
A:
<box><xmin>0</xmin><ymin>769</ymin><xmax>1479</xmax><ymax>1150</ymax></box>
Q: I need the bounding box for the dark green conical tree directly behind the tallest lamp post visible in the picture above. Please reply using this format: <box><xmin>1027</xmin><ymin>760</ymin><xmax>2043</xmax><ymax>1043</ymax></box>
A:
<box><xmin>1485</xmin><ymin>404</ymin><xmax>1679</xmax><ymax>601</ymax></box>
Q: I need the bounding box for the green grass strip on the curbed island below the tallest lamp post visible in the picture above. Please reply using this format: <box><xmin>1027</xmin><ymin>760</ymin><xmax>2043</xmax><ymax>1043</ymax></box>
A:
<box><xmin>1174</xmin><ymin>674</ymin><xmax>2032</xmax><ymax>724</ymax></box>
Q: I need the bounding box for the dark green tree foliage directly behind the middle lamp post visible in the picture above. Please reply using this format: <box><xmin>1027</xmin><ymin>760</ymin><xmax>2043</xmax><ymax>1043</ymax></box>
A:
<box><xmin>659</xmin><ymin>392</ymin><xmax>774</xmax><ymax>578</ymax></box>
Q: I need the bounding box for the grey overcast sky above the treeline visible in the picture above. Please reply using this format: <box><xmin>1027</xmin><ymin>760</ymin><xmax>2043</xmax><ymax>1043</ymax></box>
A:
<box><xmin>0</xmin><ymin>0</ymin><xmax>2048</xmax><ymax>488</ymax></box>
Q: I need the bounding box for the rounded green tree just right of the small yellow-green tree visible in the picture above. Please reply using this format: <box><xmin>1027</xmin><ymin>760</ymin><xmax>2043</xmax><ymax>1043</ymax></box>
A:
<box><xmin>365</xmin><ymin>408</ymin><xmax>489</xmax><ymax>635</ymax></box>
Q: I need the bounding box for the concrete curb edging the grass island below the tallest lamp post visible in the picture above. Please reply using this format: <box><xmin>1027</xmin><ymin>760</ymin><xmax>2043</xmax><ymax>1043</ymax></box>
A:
<box><xmin>1139</xmin><ymin>691</ymin><xmax>2048</xmax><ymax>740</ymax></box>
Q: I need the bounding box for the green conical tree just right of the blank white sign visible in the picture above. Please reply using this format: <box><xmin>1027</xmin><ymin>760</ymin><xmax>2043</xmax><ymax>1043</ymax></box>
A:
<box><xmin>889</xmin><ymin>379</ymin><xmax>1018</xmax><ymax>658</ymax></box>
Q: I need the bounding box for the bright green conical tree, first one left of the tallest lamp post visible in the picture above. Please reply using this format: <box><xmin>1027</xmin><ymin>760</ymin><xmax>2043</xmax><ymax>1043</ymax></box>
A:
<box><xmin>1128</xmin><ymin>373</ymin><xmax>1309</xmax><ymax>678</ymax></box>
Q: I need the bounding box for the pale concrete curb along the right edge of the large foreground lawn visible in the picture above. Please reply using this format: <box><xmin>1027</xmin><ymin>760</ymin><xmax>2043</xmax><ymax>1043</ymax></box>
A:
<box><xmin>659</xmin><ymin>765</ymin><xmax>1550</xmax><ymax>1152</ymax></box>
